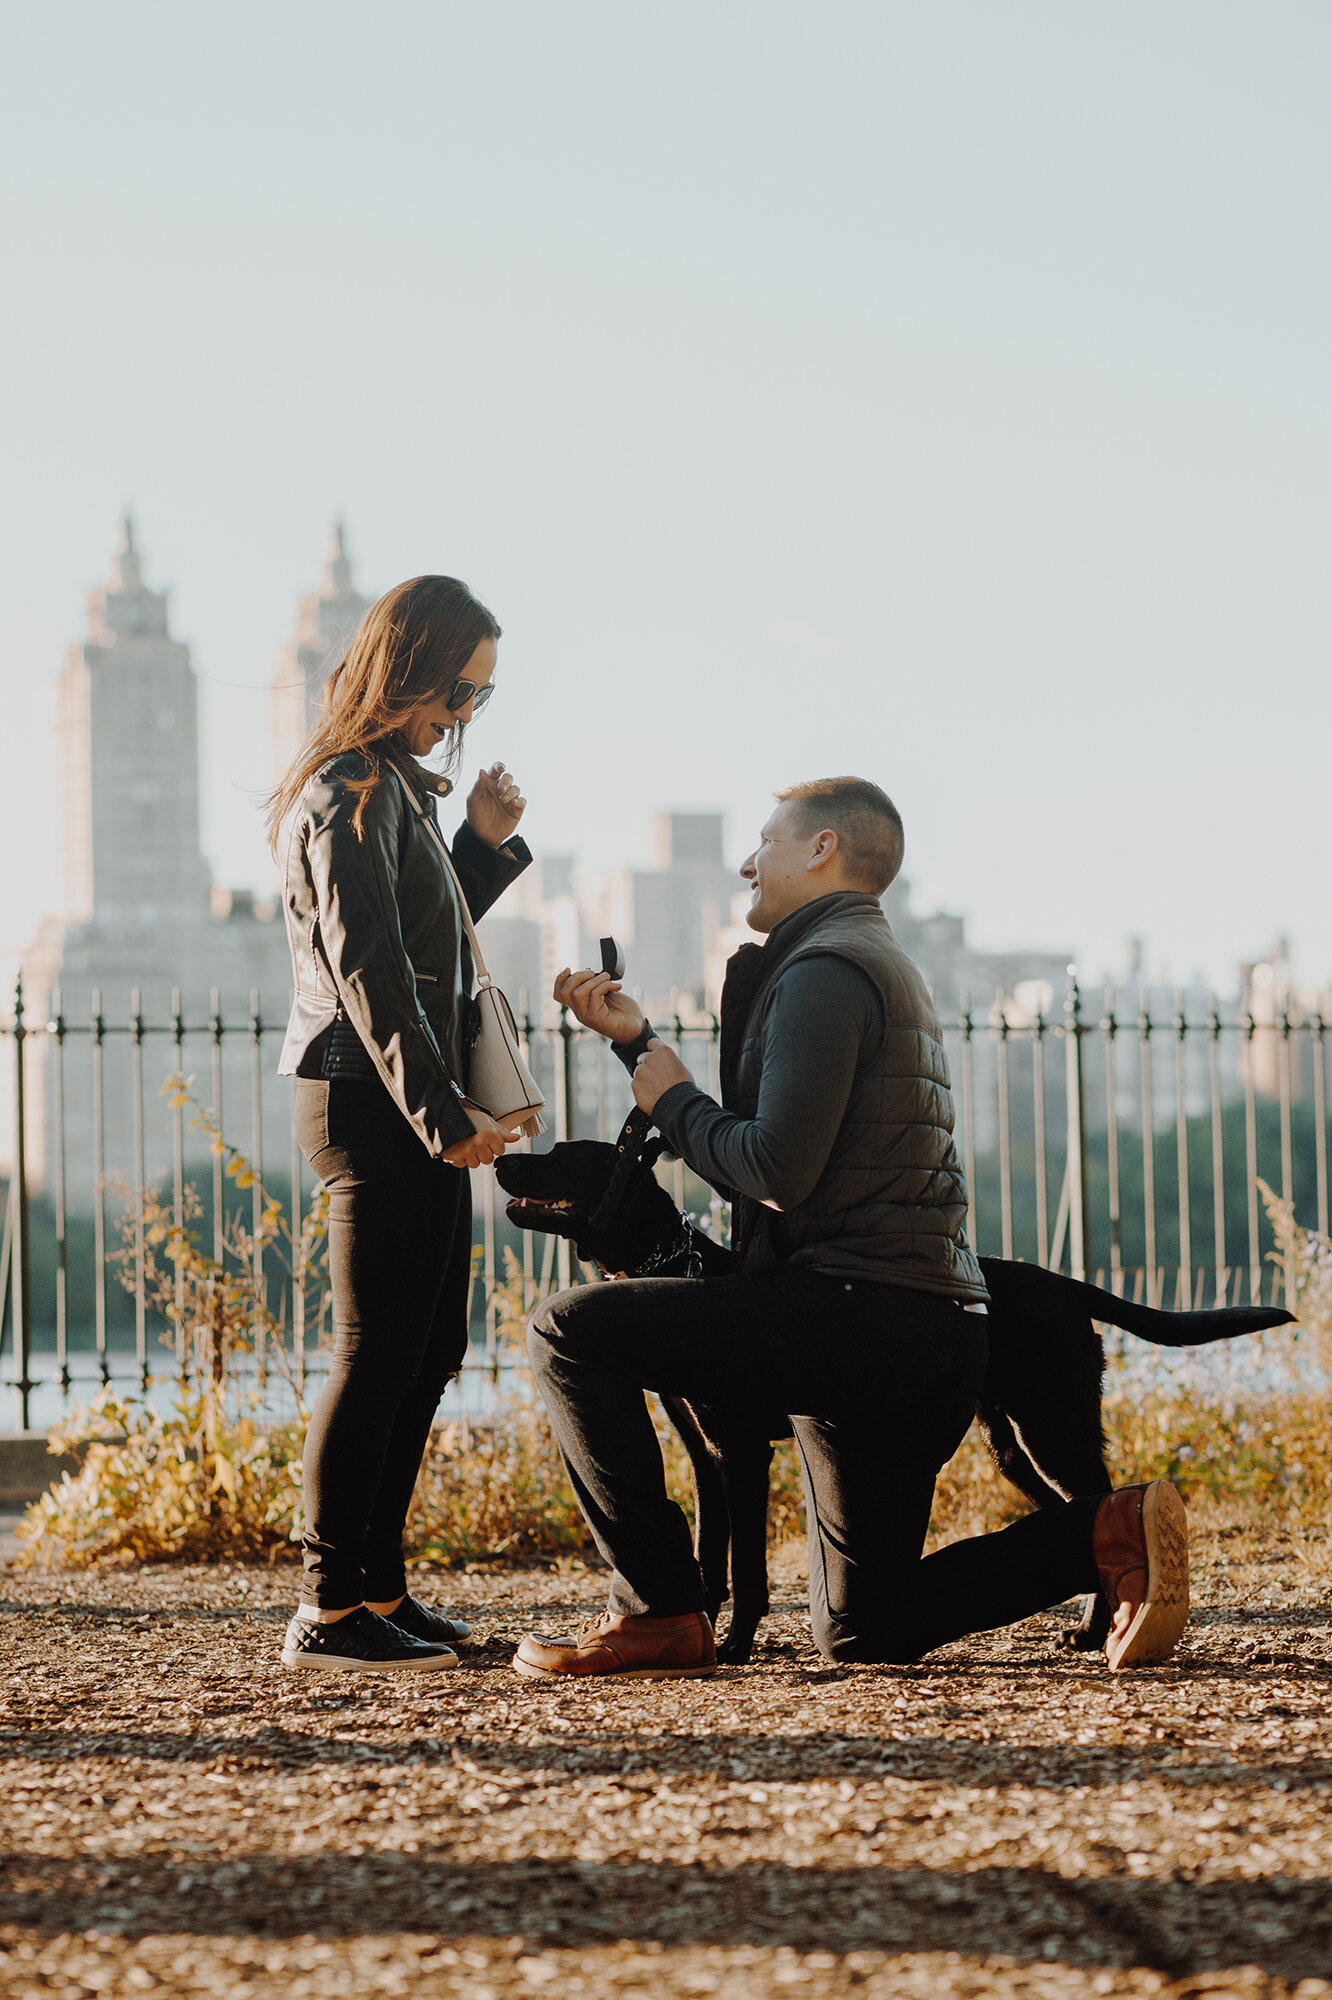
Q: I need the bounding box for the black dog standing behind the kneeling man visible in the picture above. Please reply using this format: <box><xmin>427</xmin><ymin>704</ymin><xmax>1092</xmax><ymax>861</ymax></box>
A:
<box><xmin>496</xmin><ymin>1136</ymin><xmax>1292</xmax><ymax>1664</ymax></box>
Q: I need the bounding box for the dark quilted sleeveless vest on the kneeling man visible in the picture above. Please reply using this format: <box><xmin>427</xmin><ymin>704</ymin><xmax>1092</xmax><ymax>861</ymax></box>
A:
<box><xmin>726</xmin><ymin>896</ymin><xmax>988</xmax><ymax>1302</ymax></box>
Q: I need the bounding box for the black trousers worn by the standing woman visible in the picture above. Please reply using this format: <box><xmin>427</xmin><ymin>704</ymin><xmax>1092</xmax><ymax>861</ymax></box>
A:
<box><xmin>296</xmin><ymin>1078</ymin><xmax>472</xmax><ymax>1610</ymax></box>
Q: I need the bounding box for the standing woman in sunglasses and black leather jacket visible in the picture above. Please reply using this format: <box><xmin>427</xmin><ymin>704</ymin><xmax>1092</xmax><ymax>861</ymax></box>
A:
<box><xmin>270</xmin><ymin>576</ymin><xmax>532</xmax><ymax>1672</ymax></box>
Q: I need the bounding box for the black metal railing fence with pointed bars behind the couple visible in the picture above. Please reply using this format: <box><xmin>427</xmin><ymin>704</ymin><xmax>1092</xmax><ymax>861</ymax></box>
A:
<box><xmin>0</xmin><ymin>974</ymin><xmax>1328</xmax><ymax>1428</ymax></box>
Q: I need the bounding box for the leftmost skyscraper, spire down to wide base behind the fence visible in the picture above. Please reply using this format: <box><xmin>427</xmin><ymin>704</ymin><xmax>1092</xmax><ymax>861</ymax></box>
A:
<box><xmin>22</xmin><ymin>518</ymin><xmax>290</xmax><ymax>1210</ymax></box>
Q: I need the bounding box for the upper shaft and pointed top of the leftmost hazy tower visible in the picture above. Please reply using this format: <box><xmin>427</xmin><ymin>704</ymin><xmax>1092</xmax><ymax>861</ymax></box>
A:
<box><xmin>60</xmin><ymin>514</ymin><xmax>208</xmax><ymax>934</ymax></box>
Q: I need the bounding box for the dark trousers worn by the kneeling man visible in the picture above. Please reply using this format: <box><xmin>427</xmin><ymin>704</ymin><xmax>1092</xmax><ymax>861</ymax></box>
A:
<box><xmin>528</xmin><ymin>1270</ymin><xmax>1098</xmax><ymax>1662</ymax></box>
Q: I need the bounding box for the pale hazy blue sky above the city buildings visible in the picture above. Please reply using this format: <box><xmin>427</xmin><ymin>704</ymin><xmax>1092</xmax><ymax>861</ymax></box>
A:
<box><xmin>0</xmin><ymin>0</ymin><xmax>1332</xmax><ymax>980</ymax></box>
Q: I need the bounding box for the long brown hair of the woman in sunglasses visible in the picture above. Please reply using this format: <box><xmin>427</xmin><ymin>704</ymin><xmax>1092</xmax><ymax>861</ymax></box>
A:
<box><xmin>268</xmin><ymin>576</ymin><xmax>500</xmax><ymax>852</ymax></box>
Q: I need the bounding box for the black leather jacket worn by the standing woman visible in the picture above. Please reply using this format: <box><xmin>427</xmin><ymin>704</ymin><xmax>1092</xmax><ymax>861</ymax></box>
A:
<box><xmin>278</xmin><ymin>754</ymin><xmax>532</xmax><ymax>1158</ymax></box>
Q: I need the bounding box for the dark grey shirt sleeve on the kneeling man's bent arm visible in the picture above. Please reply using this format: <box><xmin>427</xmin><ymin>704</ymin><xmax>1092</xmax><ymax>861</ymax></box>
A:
<box><xmin>622</xmin><ymin>954</ymin><xmax>884</xmax><ymax>1208</ymax></box>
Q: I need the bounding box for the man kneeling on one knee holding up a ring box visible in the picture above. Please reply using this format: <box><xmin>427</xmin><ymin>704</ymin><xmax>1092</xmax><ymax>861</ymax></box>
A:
<box><xmin>514</xmin><ymin>778</ymin><xmax>1188</xmax><ymax>1678</ymax></box>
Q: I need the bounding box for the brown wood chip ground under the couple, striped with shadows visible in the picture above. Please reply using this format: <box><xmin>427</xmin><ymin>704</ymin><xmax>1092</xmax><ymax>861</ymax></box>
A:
<box><xmin>0</xmin><ymin>1522</ymin><xmax>1332</xmax><ymax>2000</ymax></box>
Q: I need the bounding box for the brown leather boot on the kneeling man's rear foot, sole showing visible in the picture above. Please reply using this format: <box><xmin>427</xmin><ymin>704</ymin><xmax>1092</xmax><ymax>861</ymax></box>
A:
<box><xmin>1092</xmin><ymin>1480</ymin><xmax>1188</xmax><ymax>1668</ymax></box>
